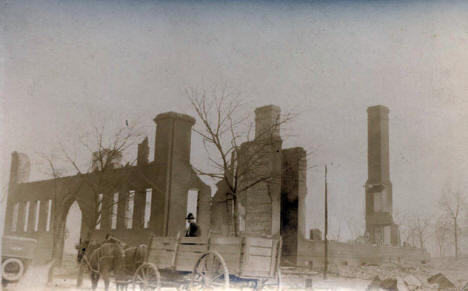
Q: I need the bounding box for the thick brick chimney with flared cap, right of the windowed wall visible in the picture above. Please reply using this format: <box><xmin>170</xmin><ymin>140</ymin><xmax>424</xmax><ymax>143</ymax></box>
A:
<box><xmin>150</xmin><ymin>112</ymin><xmax>195</xmax><ymax>236</ymax></box>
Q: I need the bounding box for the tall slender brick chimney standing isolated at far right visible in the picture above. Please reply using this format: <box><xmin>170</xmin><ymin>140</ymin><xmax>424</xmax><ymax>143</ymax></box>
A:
<box><xmin>365</xmin><ymin>105</ymin><xmax>399</xmax><ymax>245</ymax></box>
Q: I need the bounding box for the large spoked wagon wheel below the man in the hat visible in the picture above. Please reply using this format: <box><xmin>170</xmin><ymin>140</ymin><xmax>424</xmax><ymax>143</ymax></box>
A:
<box><xmin>189</xmin><ymin>251</ymin><xmax>229</xmax><ymax>290</ymax></box>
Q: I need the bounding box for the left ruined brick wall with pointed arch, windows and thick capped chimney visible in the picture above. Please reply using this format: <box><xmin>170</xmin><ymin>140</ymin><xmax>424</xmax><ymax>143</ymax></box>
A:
<box><xmin>4</xmin><ymin>112</ymin><xmax>211</xmax><ymax>261</ymax></box>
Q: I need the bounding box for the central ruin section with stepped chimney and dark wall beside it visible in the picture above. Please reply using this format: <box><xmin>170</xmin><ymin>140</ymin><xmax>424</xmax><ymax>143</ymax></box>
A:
<box><xmin>211</xmin><ymin>105</ymin><xmax>307</xmax><ymax>261</ymax></box>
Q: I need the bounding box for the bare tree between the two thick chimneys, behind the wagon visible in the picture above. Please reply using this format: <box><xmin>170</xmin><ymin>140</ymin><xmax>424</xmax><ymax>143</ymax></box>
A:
<box><xmin>187</xmin><ymin>89</ymin><xmax>293</xmax><ymax>235</ymax></box>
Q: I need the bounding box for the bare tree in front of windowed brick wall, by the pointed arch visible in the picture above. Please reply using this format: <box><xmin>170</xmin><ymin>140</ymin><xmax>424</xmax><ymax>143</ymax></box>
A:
<box><xmin>40</xmin><ymin>120</ymin><xmax>142</xmax><ymax>250</ymax></box>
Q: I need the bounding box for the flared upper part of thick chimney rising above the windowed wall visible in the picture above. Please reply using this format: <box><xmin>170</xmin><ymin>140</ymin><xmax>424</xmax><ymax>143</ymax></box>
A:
<box><xmin>154</xmin><ymin>112</ymin><xmax>195</xmax><ymax>165</ymax></box>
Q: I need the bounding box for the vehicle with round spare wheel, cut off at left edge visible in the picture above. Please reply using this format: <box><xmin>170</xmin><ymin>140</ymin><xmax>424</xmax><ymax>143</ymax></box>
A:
<box><xmin>2</xmin><ymin>236</ymin><xmax>37</xmax><ymax>284</ymax></box>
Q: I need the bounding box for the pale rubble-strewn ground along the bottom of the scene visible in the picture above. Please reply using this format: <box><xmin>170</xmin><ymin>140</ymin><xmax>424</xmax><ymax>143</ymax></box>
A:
<box><xmin>3</xmin><ymin>257</ymin><xmax>468</xmax><ymax>291</ymax></box>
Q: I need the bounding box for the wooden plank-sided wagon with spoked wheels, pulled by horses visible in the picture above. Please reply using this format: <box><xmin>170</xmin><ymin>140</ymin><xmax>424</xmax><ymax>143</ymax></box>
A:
<box><xmin>133</xmin><ymin>236</ymin><xmax>282</xmax><ymax>290</ymax></box>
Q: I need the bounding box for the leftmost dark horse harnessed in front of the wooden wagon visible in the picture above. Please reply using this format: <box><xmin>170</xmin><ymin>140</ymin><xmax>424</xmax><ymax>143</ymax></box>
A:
<box><xmin>78</xmin><ymin>241</ymin><xmax>125</xmax><ymax>291</ymax></box>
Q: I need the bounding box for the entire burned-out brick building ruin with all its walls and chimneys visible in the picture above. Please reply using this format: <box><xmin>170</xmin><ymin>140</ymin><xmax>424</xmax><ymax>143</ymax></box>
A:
<box><xmin>5</xmin><ymin>105</ymin><xmax>427</xmax><ymax>266</ymax></box>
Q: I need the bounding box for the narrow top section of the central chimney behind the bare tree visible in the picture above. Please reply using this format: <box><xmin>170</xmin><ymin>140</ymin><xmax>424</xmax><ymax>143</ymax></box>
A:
<box><xmin>255</xmin><ymin>105</ymin><xmax>281</xmax><ymax>139</ymax></box>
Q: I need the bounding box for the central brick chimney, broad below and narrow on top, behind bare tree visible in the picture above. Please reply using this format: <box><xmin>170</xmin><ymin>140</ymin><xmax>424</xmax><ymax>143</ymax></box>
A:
<box><xmin>239</xmin><ymin>105</ymin><xmax>282</xmax><ymax>236</ymax></box>
